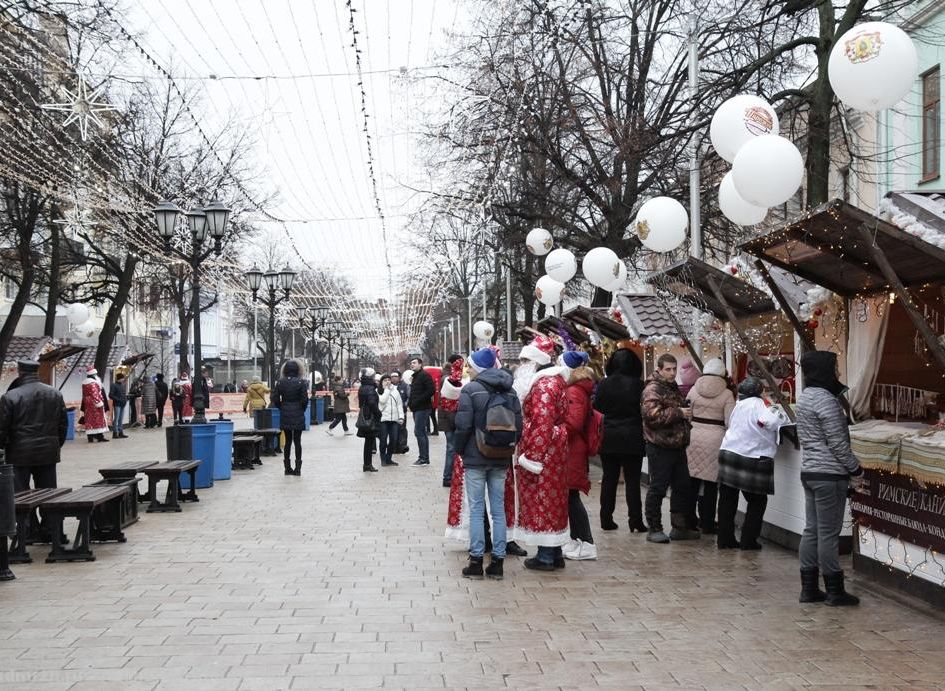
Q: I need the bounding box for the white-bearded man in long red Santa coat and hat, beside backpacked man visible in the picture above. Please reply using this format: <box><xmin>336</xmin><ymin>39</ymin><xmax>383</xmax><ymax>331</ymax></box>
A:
<box><xmin>514</xmin><ymin>335</ymin><xmax>571</xmax><ymax>571</ymax></box>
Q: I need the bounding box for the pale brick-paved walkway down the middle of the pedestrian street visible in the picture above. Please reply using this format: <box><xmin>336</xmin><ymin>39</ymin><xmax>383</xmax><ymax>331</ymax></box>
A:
<box><xmin>0</xmin><ymin>421</ymin><xmax>945</xmax><ymax>690</ymax></box>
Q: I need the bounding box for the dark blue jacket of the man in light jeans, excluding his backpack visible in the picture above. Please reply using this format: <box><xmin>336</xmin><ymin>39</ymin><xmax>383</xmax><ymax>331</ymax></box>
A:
<box><xmin>453</xmin><ymin>368</ymin><xmax>522</xmax><ymax>468</ymax></box>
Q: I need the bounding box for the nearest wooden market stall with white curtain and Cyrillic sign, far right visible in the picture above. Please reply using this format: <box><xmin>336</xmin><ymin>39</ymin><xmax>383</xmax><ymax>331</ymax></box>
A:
<box><xmin>742</xmin><ymin>200</ymin><xmax>945</xmax><ymax>606</ymax></box>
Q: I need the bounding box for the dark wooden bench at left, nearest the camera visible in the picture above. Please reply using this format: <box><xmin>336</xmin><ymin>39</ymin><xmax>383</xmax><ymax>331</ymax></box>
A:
<box><xmin>39</xmin><ymin>485</ymin><xmax>128</xmax><ymax>564</ymax></box>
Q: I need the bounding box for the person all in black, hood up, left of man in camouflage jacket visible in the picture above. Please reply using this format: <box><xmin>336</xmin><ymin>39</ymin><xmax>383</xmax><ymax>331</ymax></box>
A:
<box><xmin>594</xmin><ymin>348</ymin><xmax>646</xmax><ymax>533</ymax></box>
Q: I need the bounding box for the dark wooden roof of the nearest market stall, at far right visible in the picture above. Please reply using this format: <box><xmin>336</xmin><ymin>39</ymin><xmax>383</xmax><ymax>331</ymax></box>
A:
<box><xmin>741</xmin><ymin>199</ymin><xmax>945</xmax><ymax>297</ymax></box>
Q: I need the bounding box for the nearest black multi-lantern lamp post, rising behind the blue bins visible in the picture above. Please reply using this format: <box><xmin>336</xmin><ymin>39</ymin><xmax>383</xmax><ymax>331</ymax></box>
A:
<box><xmin>153</xmin><ymin>195</ymin><xmax>230</xmax><ymax>424</ymax></box>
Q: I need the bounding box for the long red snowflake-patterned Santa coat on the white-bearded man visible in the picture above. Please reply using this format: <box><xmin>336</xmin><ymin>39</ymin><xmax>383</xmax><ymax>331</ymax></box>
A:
<box><xmin>514</xmin><ymin>367</ymin><xmax>571</xmax><ymax>547</ymax></box>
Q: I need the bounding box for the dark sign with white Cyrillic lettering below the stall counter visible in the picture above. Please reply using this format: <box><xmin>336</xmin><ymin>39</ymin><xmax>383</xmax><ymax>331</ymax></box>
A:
<box><xmin>850</xmin><ymin>469</ymin><xmax>945</xmax><ymax>552</ymax></box>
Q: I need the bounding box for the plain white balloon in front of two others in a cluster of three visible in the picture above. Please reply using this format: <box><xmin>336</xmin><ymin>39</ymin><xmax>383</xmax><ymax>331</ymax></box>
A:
<box><xmin>732</xmin><ymin>134</ymin><xmax>804</xmax><ymax>207</ymax></box>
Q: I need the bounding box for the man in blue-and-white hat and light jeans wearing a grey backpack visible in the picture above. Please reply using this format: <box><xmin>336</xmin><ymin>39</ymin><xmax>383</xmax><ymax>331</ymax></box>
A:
<box><xmin>453</xmin><ymin>348</ymin><xmax>522</xmax><ymax>580</ymax></box>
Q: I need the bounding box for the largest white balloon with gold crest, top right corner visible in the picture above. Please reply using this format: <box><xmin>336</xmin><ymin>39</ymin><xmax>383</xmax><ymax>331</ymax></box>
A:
<box><xmin>827</xmin><ymin>22</ymin><xmax>919</xmax><ymax>111</ymax></box>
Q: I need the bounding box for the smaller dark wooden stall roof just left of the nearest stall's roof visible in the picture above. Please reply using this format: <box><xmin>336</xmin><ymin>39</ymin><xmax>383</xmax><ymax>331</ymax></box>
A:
<box><xmin>649</xmin><ymin>257</ymin><xmax>775</xmax><ymax>321</ymax></box>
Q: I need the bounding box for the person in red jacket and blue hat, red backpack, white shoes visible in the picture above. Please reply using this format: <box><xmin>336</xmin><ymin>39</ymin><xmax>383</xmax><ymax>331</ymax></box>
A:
<box><xmin>561</xmin><ymin>350</ymin><xmax>597</xmax><ymax>560</ymax></box>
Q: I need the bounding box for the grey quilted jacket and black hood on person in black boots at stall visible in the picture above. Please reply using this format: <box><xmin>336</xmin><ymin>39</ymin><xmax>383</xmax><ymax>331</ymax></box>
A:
<box><xmin>796</xmin><ymin>350</ymin><xmax>863</xmax><ymax>480</ymax></box>
